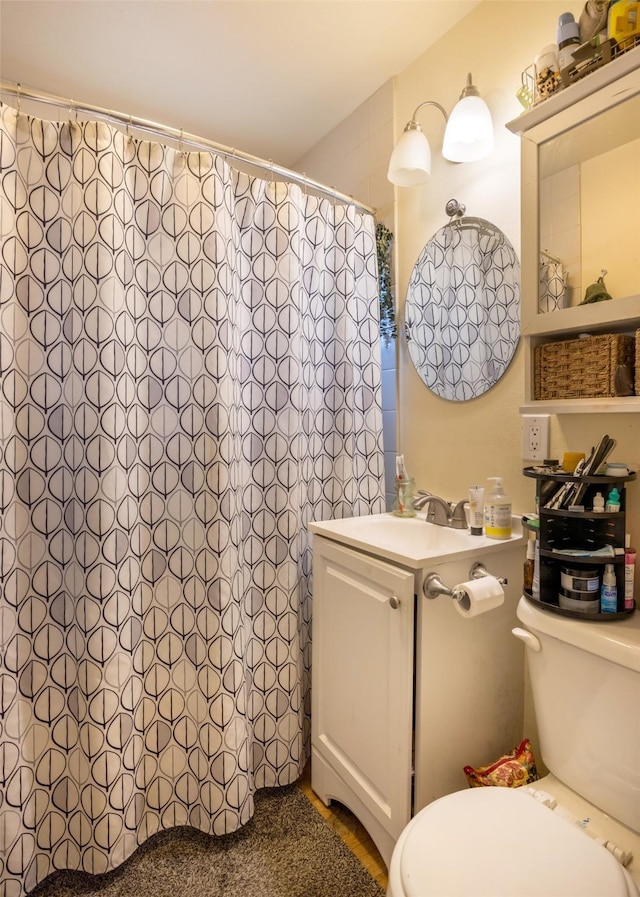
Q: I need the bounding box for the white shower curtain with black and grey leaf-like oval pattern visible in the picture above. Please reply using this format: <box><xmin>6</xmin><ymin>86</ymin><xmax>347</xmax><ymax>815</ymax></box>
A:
<box><xmin>0</xmin><ymin>101</ymin><xmax>384</xmax><ymax>897</ymax></box>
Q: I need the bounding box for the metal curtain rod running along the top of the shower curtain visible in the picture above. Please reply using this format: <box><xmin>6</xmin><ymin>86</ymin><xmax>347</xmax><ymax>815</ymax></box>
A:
<box><xmin>0</xmin><ymin>81</ymin><xmax>375</xmax><ymax>215</ymax></box>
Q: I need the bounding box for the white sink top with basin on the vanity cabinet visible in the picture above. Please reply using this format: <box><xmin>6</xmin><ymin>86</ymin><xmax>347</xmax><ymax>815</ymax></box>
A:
<box><xmin>309</xmin><ymin>513</ymin><xmax>522</xmax><ymax>570</ymax></box>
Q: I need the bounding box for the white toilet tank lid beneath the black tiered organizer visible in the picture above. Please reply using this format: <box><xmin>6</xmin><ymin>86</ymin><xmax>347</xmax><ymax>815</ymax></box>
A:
<box><xmin>517</xmin><ymin>597</ymin><xmax>640</xmax><ymax>673</ymax></box>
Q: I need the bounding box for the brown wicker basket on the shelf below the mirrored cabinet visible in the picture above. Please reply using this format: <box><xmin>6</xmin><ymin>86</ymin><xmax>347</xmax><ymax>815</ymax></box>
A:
<box><xmin>534</xmin><ymin>331</ymin><xmax>640</xmax><ymax>399</ymax></box>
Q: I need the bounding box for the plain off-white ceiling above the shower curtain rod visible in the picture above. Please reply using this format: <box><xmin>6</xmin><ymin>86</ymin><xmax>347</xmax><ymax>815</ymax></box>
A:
<box><xmin>0</xmin><ymin>0</ymin><xmax>479</xmax><ymax>168</ymax></box>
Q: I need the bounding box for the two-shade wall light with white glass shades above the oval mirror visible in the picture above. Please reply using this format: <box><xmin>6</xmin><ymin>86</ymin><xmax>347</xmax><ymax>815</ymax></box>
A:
<box><xmin>387</xmin><ymin>75</ymin><xmax>493</xmax><ymax>187</ymax></box>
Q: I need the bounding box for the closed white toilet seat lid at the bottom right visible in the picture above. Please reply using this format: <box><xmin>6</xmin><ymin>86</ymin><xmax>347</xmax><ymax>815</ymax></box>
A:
<box><xmin>388</xmin><ymin>788</ymin><xmax>638</xmax><ymax>897</ymax></box>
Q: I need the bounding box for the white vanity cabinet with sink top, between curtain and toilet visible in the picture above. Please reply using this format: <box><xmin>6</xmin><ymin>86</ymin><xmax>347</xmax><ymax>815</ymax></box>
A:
<box><xmin>310</xmin><ymin>515</ymin><xmax>524</xmax><ymax>864</ymax></box>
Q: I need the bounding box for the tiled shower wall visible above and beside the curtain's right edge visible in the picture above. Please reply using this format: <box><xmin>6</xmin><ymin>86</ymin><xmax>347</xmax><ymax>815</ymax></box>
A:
<box><xmin>294</xmin><ymin>80</ymin><xmax>397</xmax><ymax>509</ymax></box>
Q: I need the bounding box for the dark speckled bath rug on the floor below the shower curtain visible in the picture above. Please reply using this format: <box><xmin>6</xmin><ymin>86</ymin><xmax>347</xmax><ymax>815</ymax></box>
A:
<box><xmin>30</xmin><ymin>785</ymin><xmax>384</xmax><ymax>897</ymax></box>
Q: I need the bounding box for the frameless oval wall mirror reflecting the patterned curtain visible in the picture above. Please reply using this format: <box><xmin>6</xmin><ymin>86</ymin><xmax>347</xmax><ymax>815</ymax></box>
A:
<box><xmin>405</xmin><ymin>214</ymin><xmax>520</xmax><ymax>402</ymax></box>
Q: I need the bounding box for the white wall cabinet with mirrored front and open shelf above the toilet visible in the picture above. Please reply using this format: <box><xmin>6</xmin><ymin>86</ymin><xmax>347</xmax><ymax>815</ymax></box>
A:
<box><xmin>507</xmin><ymin>47</ymin><xmax>640</xmax><ymax>414</ymax></box>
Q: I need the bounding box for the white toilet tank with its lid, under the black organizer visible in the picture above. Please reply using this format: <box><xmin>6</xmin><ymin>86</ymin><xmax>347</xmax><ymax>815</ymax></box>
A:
<box><xmin>517</xmin><ymin>598</ymin><xmax>640</xmax><ymax>832</ymax></box>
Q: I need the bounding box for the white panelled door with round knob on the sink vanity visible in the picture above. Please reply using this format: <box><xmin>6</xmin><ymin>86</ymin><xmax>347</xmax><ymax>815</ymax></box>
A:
<box><xmin>311</xmin><ymin>536</ymin><xmax>414</xmax><ymax>839</ymax></box>
